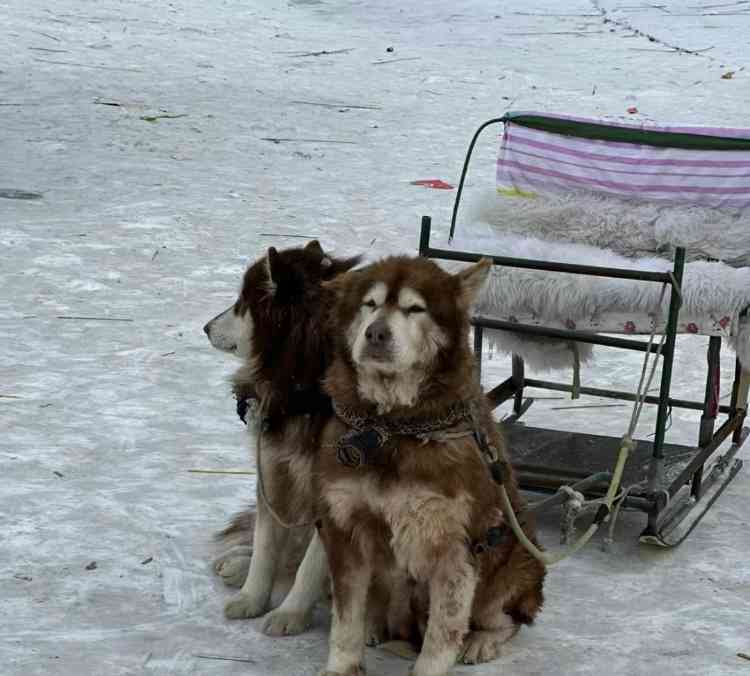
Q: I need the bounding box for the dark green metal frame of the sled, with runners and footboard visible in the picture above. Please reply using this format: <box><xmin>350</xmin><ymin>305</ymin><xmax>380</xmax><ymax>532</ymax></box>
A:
<box><xmin>419</xmin><ymin>116</ymin><xmax>750</xmax><ymax>547</ymax></box>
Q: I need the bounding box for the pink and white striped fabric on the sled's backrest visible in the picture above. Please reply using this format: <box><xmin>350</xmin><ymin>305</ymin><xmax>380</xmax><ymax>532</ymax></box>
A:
<box><xmin>497</xmin><ymin>115</ymin><xmax>750</xmax><ymax>209</ymax></box>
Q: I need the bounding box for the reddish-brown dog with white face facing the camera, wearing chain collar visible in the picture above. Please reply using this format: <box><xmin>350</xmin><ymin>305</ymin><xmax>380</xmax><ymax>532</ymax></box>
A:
<box><xmin>315</xmin><ymin>257</ymin><xmax>545</xmax><ymax>676</ymax></box>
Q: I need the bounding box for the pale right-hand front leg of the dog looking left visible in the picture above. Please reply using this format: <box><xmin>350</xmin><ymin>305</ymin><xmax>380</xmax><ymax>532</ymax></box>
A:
<box><xmin>263</xmin><ymin>531</ymin><xmax>328</xmax><ymax>636</ymax></box>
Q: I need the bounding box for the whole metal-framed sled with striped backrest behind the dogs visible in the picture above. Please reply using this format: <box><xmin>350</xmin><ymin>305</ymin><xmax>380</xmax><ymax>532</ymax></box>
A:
<box><xmin>419</xmin><ymin>113</ymin><xmax>750</xmax><ymax>547</ymax></box>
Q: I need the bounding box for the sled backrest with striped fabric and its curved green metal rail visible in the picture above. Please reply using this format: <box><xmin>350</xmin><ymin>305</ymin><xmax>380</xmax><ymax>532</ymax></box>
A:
<box><xmin>451</xmin><ymin>112</ymin><xmax>750</xmax><ymax>237</ymax></box>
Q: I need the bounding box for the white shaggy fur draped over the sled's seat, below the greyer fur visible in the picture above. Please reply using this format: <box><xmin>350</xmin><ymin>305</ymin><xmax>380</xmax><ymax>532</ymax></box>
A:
<box><xmin>452</xmin><ymin>230</ymin><xmax>750</xmax><ymax>369</ymax></box>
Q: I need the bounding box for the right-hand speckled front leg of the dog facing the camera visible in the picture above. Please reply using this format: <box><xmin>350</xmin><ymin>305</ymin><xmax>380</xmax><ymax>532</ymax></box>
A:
<box><xmin>411</xmin><ymin>543</ymin><xmax>477</xmax><ymax>676</ymax></box>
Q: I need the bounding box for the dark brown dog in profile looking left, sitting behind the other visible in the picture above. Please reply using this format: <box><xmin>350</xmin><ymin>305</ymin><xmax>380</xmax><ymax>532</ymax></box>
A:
<box><xmin>204</xmin><ymin>241</ymin><xmax>359</xmax><ymax>635</ymax></box>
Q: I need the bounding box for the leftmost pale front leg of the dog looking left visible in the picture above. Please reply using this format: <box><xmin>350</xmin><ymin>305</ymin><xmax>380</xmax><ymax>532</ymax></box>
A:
<box><xmin>224</xmin><ymin>499</ymin><xmax>288</xmax><ymax>619</ymax></box>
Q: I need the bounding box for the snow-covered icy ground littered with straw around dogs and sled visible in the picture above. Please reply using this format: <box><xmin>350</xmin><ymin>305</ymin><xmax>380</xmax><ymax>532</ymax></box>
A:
<box><xmin>0</xmin><ymin>0</ymin><xmax>750</xmax><ymax>676</ymax></box>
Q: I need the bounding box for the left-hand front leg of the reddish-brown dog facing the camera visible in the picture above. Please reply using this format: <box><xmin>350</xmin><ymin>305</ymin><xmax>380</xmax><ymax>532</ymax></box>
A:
<box><xmin>320</xmin><ymin>524</ymin><xmax>372</xmax><ymax>676</ymax></box>
